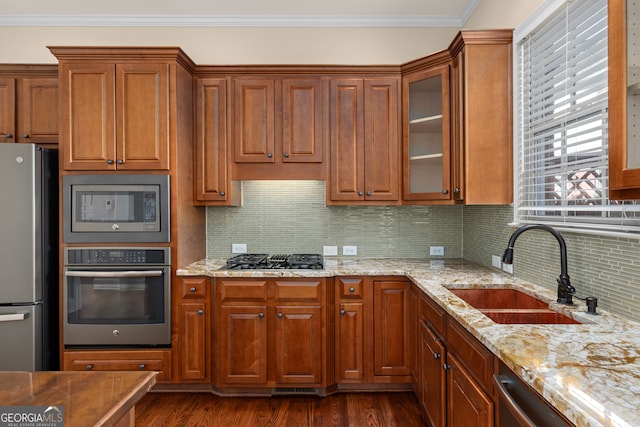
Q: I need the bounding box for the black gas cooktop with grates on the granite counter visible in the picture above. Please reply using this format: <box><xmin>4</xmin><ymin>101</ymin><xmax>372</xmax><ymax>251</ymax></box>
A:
<box><xmin>223</xmin><ymin>254</ymin><xmax>324</xmax><ymax>270</ymax></box>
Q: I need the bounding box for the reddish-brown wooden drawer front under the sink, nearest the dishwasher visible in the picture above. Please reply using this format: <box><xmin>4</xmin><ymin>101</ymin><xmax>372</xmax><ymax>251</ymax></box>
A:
<box><xmin>447</xmin><ymin>321</ymin><xmax>493</xmax><ymax>391</ymax></box>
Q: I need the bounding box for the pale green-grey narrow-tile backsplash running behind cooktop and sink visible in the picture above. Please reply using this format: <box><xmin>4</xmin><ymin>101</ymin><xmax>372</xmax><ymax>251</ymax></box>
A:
<box><xmin>207</xmin><ymin>181</ymin><xmax>640</xmax><ymax>321</ymax></box>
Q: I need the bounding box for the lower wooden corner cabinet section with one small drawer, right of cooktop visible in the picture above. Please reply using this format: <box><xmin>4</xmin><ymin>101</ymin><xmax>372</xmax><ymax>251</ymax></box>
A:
<box><xmin>335</xmin><ymin>277</ymin><xmax>411</xmax><ymax>389</ymax></box>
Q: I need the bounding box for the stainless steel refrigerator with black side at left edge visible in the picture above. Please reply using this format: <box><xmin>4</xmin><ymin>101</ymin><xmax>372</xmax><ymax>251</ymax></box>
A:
<box><xmin>0</xmin><ymin>143</ymin><xmax>60</xmax><ymax>371</ymax></box>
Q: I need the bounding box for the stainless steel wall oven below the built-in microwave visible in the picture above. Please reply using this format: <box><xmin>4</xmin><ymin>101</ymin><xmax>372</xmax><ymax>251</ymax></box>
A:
<box><xmin>63</xmin><ymin>247</ymin><xmax>171</xmax><ymax>348</ymax></box>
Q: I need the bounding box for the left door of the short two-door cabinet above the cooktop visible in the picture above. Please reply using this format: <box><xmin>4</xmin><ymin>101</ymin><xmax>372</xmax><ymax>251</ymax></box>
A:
<box><xmin>233</xmin><ymin>79</ymin><xmax>275</xmax><ymax>163</ymax></box>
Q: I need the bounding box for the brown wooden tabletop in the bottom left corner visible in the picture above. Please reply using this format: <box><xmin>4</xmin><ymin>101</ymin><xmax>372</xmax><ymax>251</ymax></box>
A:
<box><xmin>0</xmin><ymin>371</ymin><xmax>157</xmax><ymax>427</ymax></box>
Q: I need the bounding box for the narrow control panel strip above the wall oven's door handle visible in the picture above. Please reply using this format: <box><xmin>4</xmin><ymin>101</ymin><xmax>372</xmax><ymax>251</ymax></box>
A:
<box><xmin>64</xmin><ymin>247</ymin><xmax>170</xmax><ymax>265</ymax></box>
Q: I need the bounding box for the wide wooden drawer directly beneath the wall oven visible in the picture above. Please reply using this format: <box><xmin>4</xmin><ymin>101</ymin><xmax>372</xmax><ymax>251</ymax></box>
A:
<box><xmin>63</xmin><ymin>350</ymin><xmax>171</xmax><ymax>380</ymax></box>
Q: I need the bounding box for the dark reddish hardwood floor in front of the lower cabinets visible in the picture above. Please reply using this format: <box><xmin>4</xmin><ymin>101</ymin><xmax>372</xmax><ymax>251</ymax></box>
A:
<box><xmin>136</xmin><ymin>392</ymin><xmax>426</xmax><ymax>427</ymax></box>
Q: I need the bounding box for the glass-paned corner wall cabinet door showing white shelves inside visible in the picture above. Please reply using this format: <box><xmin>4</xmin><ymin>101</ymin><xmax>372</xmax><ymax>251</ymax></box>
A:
<box><xmin>402</xmin><ymin>64</ymin><xmax>451</xmax><ymax>201</ymax></box>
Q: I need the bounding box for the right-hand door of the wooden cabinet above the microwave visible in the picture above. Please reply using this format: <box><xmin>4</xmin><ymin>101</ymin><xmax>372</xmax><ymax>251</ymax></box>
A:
<box><xmin>116</xmin><ymin>63</ymin><xmax>169</xmax><ymax>170</ymax></box>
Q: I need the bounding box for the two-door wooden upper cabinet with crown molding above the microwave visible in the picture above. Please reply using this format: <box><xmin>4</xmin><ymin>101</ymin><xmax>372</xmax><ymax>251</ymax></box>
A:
<box><xmin>49</xmin><ymin>47</ymin><xmax>193</xmax><ymax>171</ymax></box>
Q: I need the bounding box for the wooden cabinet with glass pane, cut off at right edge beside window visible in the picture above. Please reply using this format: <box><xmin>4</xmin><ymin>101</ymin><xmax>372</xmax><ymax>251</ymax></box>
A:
<box><xmin>608</xmin><ymin>0</ymin><xmax>640</xmax><ymax>199</ymax></box>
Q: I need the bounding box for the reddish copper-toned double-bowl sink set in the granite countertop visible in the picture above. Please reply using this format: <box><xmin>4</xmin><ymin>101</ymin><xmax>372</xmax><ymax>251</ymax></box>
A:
<box><xmin>449</xmin><ymin>288</ymin><xmax>580</xmax><ymax>324</ymax></box>
